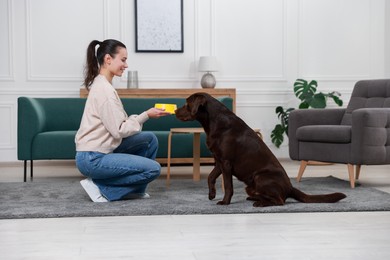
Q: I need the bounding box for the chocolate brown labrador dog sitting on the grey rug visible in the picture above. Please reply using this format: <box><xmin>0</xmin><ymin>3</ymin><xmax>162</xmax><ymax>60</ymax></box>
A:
<box><xmin>176</xmin><ymin>93</ymin><xmax>346</xmax><ymax>207</ymax></box>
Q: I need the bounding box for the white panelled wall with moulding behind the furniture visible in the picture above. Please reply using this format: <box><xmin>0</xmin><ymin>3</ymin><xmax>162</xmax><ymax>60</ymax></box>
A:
<box><xmin>0</xmin><ymin>0</ymin><xmax>390</xmax><ymax>161</ymax></box>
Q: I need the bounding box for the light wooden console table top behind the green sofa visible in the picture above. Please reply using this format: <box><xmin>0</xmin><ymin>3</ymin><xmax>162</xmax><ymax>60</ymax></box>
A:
<box><xmin>80</xmin><ymin>88</ymin><xmax>236</xmax><ymax>112</ymax></box>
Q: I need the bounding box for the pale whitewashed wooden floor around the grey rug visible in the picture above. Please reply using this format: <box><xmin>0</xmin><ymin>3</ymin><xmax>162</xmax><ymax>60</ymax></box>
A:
<box><xmin>0</xmin><ymin>159</ymin><xmax>390</xmax><ymax>260</ymax></box>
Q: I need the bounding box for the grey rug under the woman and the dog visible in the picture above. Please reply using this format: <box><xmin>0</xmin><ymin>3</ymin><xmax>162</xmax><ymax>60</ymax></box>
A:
<box><xmin>0</xmin><ymin>176</ymin><xmax>390</xmax><ymax>219</ymax></box>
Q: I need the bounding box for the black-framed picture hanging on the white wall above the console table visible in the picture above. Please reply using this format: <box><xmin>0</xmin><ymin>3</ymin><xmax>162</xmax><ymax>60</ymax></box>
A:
<box><xmin>135</xmin><ymin>0</ymin><xmax>184</xmax><ymax>52</ymax></box>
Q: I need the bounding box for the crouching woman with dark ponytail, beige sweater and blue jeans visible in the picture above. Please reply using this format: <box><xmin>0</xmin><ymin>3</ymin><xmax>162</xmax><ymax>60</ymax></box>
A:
<box><xmin>75</xmin><ymin>39</ymin><xmax>169</xmax><ymax>202</ymax></box>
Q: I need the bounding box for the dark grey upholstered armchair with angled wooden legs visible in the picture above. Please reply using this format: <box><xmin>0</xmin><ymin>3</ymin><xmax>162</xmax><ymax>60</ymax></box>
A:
<box><xmin>288</xmin><ymin>79</ymin><xmax>390</xmax><ymax>188</ymax></box>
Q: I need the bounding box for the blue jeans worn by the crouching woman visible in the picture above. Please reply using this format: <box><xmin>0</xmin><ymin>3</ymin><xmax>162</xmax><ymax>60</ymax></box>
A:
<box><xmin>76</xmin><ymin>132</ymin><xmax>161</xmax><ymax>201</ymax></box>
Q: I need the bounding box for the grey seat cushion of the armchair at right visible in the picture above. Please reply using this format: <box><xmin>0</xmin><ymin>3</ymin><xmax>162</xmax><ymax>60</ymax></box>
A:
<box><xmin>296</xmin><ymin>125</ymin><xmax>352</xmax><ymax>143</ymax></box>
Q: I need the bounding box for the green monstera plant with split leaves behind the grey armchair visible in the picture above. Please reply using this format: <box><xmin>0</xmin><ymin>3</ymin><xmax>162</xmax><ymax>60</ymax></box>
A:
<box><xmin>271</xmin><ymin>79</ymin><xmax>343</xmax><ymax>148</ymax></box>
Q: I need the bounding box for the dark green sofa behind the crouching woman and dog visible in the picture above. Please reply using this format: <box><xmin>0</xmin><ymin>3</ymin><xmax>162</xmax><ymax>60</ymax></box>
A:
<box><xmin>18</xmin><ymin>97</ymin><xmax>233</xmax><ymax>181</ymax></box>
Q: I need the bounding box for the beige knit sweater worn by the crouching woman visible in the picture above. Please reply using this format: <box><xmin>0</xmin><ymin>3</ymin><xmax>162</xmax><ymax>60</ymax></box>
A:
<box><xmin>75</xmin><ymin>75</ymin><xmax>149</xmax><ymax>153</ymax></box>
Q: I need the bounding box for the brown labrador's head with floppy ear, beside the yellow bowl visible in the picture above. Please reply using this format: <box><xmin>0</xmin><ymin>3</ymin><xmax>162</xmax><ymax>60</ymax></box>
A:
<box><xmin>175</xmin><ymin>93</ymin><xmax>211</xmax><ymax>121</ymax></box>
